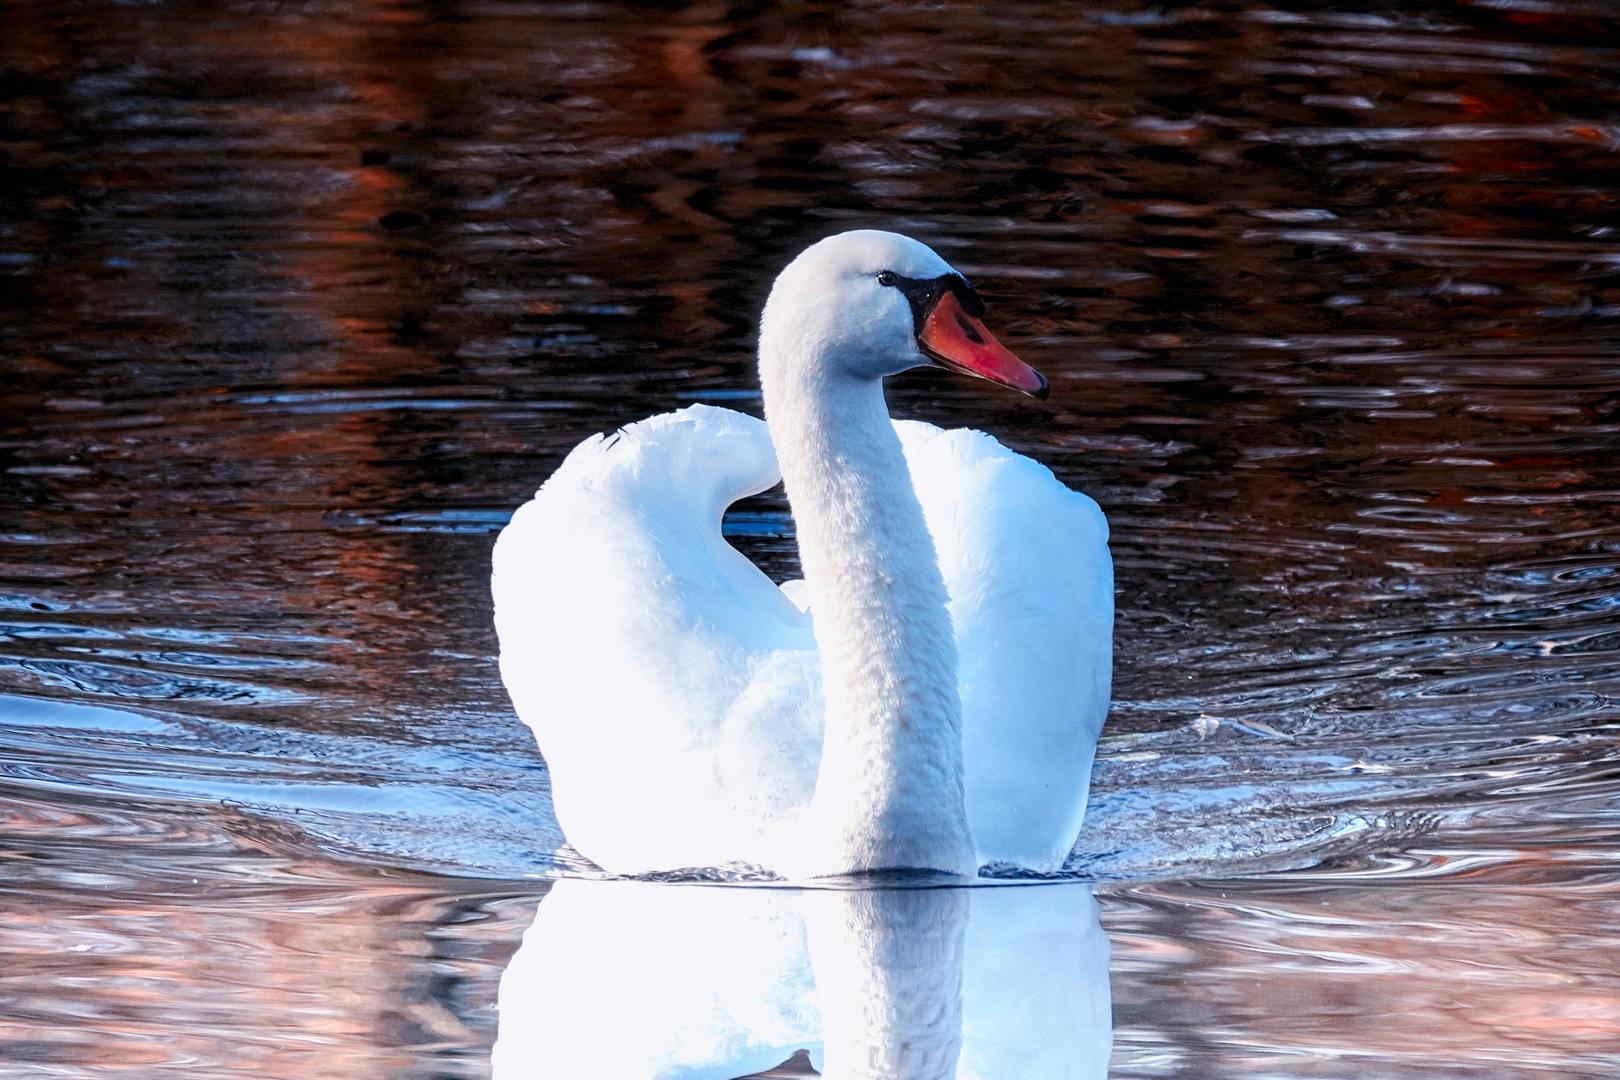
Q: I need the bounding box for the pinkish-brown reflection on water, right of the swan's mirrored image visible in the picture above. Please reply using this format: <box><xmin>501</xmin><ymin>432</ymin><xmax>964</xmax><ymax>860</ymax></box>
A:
<box><xmin>1098</xmin><ymin>858</ymin><xmax>1620</xmax><ymax>1077</ymax></box>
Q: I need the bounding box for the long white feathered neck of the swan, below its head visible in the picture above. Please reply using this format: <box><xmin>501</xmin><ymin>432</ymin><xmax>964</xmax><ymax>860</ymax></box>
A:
<box><xmin>761</xmin><ymin>364</ymin><xmax>975</xmax><ymax>874</ymax></box>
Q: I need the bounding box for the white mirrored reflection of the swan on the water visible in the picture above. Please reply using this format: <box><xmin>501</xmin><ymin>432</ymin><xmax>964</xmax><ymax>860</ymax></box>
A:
<box><xmin>494</xmin><ymin>881</ymin><xmax>1113</xmax><ymax>1080</ymax></box>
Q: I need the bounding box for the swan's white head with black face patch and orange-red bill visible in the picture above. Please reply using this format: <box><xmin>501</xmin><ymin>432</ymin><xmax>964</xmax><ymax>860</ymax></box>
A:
<box><xmin>760</xmin><ymin>228</ymin><xmax>1047</xmax><ymax>398</ymax></box>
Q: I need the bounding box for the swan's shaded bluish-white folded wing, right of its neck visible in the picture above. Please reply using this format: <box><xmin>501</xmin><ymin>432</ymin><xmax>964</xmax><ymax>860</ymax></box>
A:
<box><xmin>896</xmin><ymin>421</ymin><xmax>1113</xmax><ymax>871</ymax></box>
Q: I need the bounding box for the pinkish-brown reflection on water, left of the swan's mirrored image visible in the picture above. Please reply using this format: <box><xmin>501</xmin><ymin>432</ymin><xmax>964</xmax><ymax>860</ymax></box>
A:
<box><xmin>0</xmin><ymin>798</ymin><xmax>535</xmax><ymax>1080</ymax></box>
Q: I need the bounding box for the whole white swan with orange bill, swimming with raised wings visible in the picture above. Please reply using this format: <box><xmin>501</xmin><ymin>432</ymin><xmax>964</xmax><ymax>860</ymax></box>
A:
<box><xmin>492</xmin><ymin>230</ymin><xmax>1113</xmax><ymax>879</ymax></box>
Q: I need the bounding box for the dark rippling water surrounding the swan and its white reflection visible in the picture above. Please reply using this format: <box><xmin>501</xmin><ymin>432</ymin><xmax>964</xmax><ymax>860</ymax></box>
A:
<box><xmin>0</xmin><ymin>0</ymin><xmax>1620</xmax><ymax>1078</ymax></box>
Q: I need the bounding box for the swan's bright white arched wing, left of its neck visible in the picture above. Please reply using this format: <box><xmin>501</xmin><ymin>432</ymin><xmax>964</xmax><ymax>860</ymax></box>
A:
<box><xmin>492</xmin><ymin>405</ymin><xmax>821</xmax><ymax>873</ymax></box>
